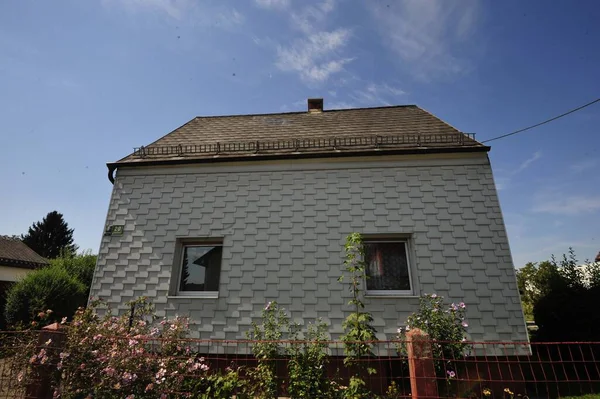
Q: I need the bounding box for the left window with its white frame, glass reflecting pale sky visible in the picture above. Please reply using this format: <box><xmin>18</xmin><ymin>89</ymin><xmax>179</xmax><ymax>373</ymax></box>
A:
<box><xmin>176</xmin><ymin>242</ymin><xmax>223</xmax><ymax>298</ymax></box>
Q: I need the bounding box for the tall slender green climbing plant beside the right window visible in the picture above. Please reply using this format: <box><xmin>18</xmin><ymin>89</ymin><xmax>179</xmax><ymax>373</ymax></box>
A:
<box><xmin>338</xmin><ymin>233</ymin><xmax>377</xmax><ymax>398</ymax></box>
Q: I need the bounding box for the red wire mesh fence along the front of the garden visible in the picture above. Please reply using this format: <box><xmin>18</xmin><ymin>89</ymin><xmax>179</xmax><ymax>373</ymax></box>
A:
<box><xmin>0</xmin><ymin>332</ymin><xmax>600</xmax><ymax>399</ymax></box>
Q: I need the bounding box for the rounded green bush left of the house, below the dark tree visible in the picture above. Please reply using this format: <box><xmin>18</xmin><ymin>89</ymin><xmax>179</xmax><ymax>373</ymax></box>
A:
<box><xmin>4</xmin><ymin>267</ymin><xmax>87</xmax><ymax>327</ymax></box>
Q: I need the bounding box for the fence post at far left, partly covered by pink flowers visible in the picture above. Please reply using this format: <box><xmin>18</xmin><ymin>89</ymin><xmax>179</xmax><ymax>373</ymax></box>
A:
<box><xmin>25</xmin><ymin>323</ymin><xmax>66</xmax><ymax>399</ymax></box>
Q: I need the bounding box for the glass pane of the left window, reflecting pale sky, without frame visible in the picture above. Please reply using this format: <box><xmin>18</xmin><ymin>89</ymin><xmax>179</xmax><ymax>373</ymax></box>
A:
<box><xmin>179</xmin><ymin>246</ymin><xmax>223</xmax><ymax>291</ymax></box>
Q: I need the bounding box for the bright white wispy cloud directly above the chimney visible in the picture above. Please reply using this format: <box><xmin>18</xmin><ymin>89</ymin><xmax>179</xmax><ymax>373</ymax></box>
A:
<box><xmin>276</xmin><ymin>29</ymin><xmax>352</xmax><ymax>82</ymax></box>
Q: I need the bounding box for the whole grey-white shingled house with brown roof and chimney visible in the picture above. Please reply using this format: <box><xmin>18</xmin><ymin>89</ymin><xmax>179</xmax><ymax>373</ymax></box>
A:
<box><xmin>91</xmin><ymin>99</ymin><xmax>527</xmax><ymax>341</ymax></box>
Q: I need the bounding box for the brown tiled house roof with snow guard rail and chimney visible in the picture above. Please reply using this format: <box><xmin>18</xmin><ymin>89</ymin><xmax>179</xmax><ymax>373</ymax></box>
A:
<box><xmin>108</xmin><ymin>103</ymin><xmax>489</xmax><ymax>177</ymax></box>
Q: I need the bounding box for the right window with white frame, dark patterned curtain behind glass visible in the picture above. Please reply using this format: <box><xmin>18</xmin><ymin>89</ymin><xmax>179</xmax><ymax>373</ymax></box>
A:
<box><xmin>363</xmin><ymin>239</ymin><xmax>413</xmax><ymax>296</ymax></box>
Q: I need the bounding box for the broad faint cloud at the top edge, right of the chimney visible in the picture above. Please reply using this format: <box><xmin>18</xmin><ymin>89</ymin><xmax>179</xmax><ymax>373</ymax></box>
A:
<box><xmin>367</xmin><ymin>0</ymin><xmax>479</xmax><ymax>80</ymax></box>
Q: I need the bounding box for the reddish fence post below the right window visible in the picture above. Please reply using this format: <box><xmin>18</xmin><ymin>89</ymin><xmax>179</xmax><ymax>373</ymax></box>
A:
<box><xmin>406</xmin><ymin>328</ymin><xmax>438</xmax><ymax>399</ymax></box>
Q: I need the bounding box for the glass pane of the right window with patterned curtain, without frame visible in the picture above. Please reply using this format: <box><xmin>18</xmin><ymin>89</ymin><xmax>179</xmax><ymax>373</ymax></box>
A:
<box><xmin>365</xmin><ymin>242</ymin><xmax>410</xmax><ymax>291</ymax></box>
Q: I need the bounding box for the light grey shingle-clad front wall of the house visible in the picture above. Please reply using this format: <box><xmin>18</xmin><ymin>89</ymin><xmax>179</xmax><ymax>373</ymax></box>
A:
<box><xmin>91</xmin><ymin>152</ymin><xmax>527</xmax><ymax>341</ymax></box>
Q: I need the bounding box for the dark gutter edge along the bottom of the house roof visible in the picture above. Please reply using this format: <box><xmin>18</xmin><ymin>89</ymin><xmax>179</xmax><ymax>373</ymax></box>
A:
<box><xmin>106</xmin><ymin>145</ymin><xmax>491</xmax><ymax>184</ymax></box>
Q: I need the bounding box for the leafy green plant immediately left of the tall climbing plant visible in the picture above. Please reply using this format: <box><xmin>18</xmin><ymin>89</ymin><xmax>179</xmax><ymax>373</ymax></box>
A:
<box><xmin>288</xmin><ymin>320</ymin><xmax>330</xmax><ymax>399</ymax></box>
